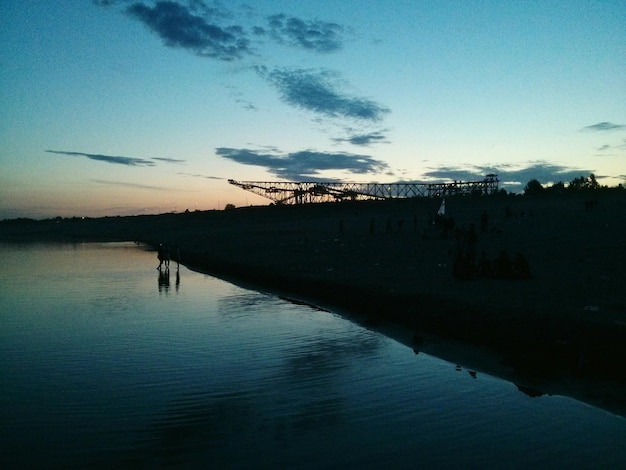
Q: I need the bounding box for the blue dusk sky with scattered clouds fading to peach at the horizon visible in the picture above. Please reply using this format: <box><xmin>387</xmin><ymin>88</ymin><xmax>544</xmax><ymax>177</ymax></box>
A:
<box><xmin>0</xmin><ymin>0</ymin><xmax>626</xmax><ymax>220</ymax></box>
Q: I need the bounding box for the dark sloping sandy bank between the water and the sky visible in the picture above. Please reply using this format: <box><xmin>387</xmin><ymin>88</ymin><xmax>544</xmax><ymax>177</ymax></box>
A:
<box><xmin>0</xmin><ymin>193</ymin><xmax>626</xmax><ymax>409</ymax></box>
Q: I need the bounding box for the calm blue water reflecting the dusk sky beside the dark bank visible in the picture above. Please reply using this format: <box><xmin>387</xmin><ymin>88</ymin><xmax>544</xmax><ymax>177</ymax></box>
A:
<box><xmin>0</xmin><ymin>244</ymin><xmax>626</xmax><ymax>468</ymax></box>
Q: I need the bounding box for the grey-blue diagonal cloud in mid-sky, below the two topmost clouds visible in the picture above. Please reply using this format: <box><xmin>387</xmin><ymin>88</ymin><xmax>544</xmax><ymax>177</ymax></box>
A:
<box><xmin>256</xmin><ymin>67</ymin><xmax>389</xmax><ymax>121</ymax></box>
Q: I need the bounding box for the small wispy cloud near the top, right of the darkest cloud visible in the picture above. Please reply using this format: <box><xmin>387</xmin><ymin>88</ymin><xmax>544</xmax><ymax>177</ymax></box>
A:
<box><xmin>256</xmin><ymin>14</ymin><xmax>344</xmax><ymax>53</ymax></box>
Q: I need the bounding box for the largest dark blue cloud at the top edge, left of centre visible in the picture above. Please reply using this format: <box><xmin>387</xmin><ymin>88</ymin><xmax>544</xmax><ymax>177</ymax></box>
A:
<box><xmin>126</xmin><ymin>1</ymin><xmax>251</xmax><ymax>61</ymax></box>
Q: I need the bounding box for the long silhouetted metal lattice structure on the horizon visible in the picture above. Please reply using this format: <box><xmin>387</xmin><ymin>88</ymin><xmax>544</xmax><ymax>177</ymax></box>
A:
<box><xmin>228</xmin><ymin>174</ymin><xmax>498</xmax><ymax>204</ymax></box>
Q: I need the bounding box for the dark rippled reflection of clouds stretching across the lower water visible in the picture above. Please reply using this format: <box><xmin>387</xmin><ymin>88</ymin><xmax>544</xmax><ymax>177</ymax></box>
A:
<box><xmin>118</xmin><ymin>322</ymin><xmax>382</xmax><ymax>466</ymax></box>
